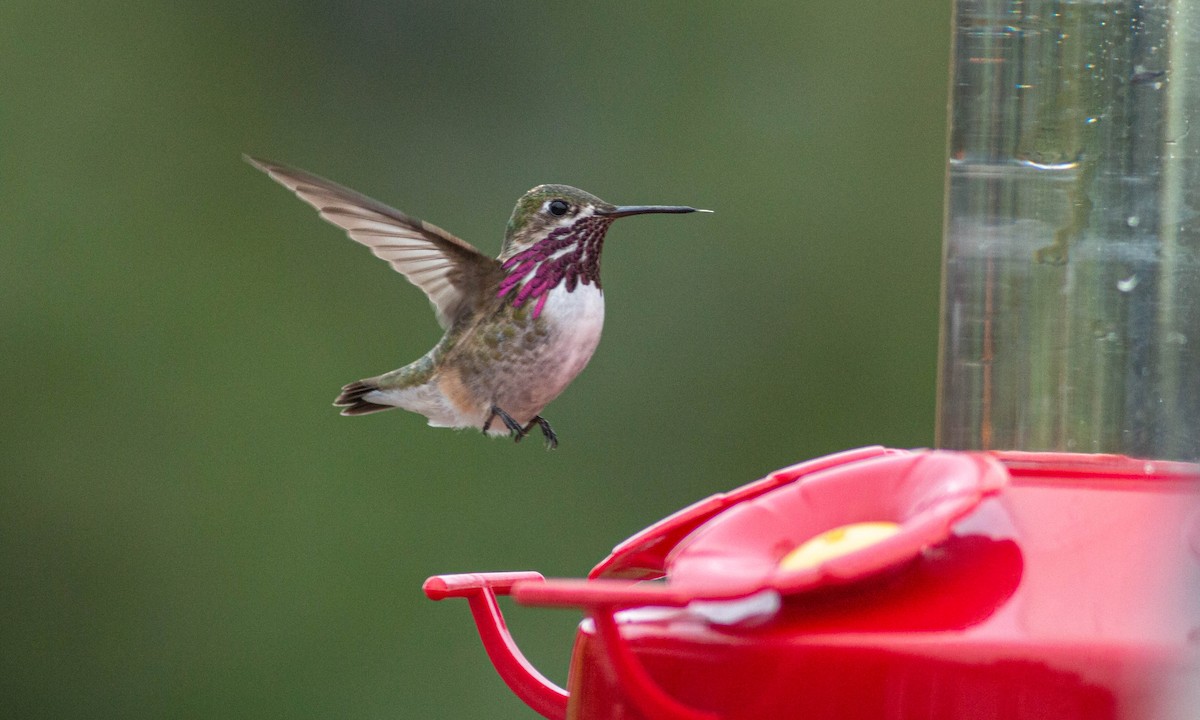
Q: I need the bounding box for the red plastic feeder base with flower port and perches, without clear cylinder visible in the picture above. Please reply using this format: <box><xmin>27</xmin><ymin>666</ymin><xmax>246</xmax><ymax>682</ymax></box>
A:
<box><xmin>425</xmin><ymin>448</ymin><xmax>1200</xmax><ymax>720</ymax></box>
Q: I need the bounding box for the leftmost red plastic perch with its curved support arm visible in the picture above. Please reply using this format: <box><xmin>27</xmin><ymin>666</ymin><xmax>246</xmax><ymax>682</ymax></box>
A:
<box><xmin>421</xmin><ymin>572</ymin><xmax>568</xmax><ymax>720</ymax></box>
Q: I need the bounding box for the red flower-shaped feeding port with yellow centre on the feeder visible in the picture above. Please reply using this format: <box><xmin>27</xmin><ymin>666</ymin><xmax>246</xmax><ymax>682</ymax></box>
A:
<box><xmin>667</xmin><ymin>452</ymin><xmax>1008</xmax><ymax>599</ymax></box>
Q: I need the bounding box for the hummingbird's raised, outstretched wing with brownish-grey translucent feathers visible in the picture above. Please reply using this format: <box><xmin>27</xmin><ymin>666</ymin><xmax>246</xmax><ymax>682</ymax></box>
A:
<box><xmin>244</xmin><ymin>155</ymin><xmax>504</xmax><ymax>328</ymax></box>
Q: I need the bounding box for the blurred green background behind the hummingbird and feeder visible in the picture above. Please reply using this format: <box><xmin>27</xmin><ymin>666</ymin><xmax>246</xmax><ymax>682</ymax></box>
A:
<box><xmin>0</xmin><ymin>0</ymin><xmax>949</xmax><ymax>719</ymax></box>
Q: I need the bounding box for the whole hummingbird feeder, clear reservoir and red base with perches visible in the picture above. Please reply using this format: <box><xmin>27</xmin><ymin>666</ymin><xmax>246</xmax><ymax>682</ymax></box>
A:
<box><xmin>425</xmin><ymin>0</ymin><xmax>1200</xmax><ymax>720</ymax></box>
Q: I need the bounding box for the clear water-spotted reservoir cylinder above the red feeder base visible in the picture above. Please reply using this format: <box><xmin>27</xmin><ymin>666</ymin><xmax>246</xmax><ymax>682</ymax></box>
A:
<box><xmin>937</xmin><ymin>0</ymin><xmax>1200</xmax><ymax>460</ymax></box>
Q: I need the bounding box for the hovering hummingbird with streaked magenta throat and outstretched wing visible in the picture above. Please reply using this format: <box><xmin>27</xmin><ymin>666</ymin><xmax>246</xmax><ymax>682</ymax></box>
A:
<box><xmin>245</xmin><ymin>156</ymin><xmax>710</xmax><ymax>449</ymax></box>
